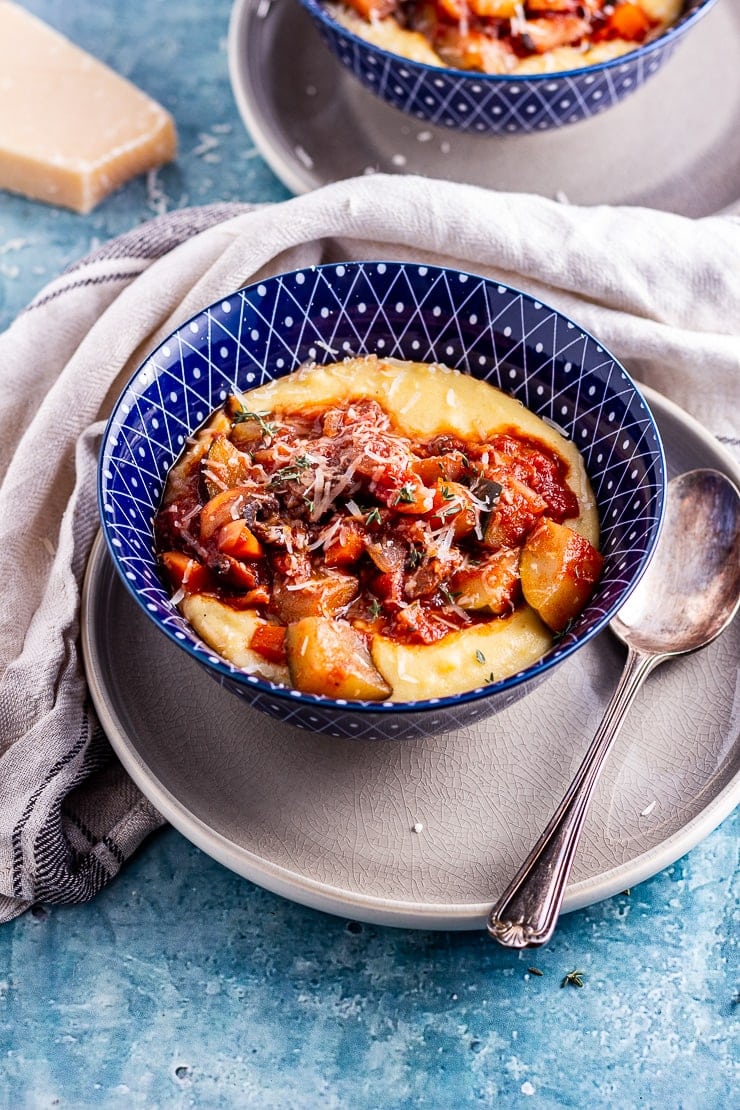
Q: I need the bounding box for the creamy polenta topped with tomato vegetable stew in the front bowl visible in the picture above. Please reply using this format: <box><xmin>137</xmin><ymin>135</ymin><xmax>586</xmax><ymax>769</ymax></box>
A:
<box><xmin>155</xmin><ymin>355</ymin><xmax>601</xmax><ymax>702</ymax></box>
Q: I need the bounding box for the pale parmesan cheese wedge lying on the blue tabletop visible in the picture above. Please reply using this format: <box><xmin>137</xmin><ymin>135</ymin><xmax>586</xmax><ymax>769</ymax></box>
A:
<box><xmin>0</xmin><ymin>0</ymin><xmax>178</xmax><ymax>212</ymax></box>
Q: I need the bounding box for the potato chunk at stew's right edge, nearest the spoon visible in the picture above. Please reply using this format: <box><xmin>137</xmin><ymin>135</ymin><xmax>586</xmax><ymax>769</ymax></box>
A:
<box><xmin>519</xmin><ymin>521</ymin><xmax>604</xmax><ymax>632</ymax></box>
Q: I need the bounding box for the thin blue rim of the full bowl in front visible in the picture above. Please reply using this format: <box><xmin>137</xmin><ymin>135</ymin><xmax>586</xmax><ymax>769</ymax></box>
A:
<box><xmin>98</xmin><ymin>259</ymin><xmax>667</xmax><ymax>715</ymax></box>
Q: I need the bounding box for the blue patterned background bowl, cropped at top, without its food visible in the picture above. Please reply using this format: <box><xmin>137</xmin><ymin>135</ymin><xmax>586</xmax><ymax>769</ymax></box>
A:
<box><xmin>301</xmin><ymin>0</ymin><xmax>714</xmax><ymax>134</ymax></box>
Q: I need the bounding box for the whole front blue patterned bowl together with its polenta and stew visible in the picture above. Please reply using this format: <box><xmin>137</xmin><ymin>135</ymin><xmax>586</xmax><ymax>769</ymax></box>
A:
<box><xmin>99</xmin><ymin>262</ymin><xmax>665</xmax><ymax>739</ymax></box>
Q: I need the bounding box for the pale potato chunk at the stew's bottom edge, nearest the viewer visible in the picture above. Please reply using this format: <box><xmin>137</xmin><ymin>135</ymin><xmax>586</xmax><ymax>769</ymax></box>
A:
<box><xmin>285</xmin><ymin>617</ymin><xmax>391</xmax><ymax>702</ymax></box>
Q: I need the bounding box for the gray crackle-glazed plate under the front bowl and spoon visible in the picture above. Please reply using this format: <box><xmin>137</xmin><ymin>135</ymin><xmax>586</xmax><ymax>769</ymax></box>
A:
<box><xmin>82</xmin><ymin>390</ymin><xmax>740</xmax><ymax>929</ymax></box>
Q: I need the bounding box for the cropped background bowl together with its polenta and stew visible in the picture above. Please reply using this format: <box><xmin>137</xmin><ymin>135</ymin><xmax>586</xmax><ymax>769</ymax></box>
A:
<box><xmin>300</xmin><ymin>0</ymin><xmax>714</xmax><ymax>134</ymax></box>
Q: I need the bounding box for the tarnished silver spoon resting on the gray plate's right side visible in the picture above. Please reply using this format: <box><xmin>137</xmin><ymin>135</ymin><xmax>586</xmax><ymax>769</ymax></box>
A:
<box><xmin>487</xmin><ymin>470</ymin><xmax>740</xmax><ymax>948</ymax></box>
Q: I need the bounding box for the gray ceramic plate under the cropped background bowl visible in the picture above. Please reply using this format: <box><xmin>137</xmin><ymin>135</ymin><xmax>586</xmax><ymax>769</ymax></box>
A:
<box><xmin>229</xmin><ymin>0</ymin><xmax>740</xmax><ymax>215</ymax></box>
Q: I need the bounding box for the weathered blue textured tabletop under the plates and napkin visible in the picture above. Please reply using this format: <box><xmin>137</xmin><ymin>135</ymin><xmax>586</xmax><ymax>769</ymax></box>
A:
<box><xmin>0</xmin><ymin>0</ymin><xmax>740</xmax><ymax>1110</ymax></box>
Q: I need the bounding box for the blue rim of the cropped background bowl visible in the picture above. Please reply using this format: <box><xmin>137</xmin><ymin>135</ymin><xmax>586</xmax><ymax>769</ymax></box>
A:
<box><xmin>298</xmin><ymin>0</ymin><xmax>717</xmax><ymax>85</ymax></box>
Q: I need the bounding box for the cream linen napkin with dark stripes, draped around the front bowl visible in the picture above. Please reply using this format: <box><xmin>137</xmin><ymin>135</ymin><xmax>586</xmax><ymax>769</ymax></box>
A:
<box><xmin>0</xmin><ymin>175</ymin><xmax>740</xmax><ymax>921</ymax></box>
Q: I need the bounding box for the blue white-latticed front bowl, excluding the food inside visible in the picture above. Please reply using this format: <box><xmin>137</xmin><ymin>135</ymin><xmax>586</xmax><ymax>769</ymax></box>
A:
<box><xmin>99</xmin><ymin>262</ymin><xmax>665</xmax><ymax>739</ymax></box>
